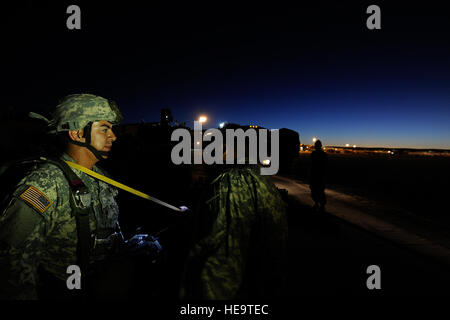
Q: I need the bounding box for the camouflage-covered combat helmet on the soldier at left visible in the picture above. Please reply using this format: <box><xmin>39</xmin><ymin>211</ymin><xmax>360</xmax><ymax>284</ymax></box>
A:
<box><xmin>51</xmin><ymin>93</ymin><xmax>123</xmax><ymax>132</ymax></box>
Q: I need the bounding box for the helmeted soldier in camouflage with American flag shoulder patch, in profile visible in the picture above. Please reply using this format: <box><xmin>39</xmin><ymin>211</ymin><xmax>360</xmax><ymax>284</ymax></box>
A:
<box><xmin>0</xmin><ymin>94</ymin><xmax>134</xmax><ymax>299</ymax></box>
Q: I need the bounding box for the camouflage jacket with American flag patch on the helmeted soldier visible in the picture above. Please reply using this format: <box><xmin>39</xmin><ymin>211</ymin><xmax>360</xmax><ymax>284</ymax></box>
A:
<box><xmin>0</xmin><ymin>154</ymin><xmax>119</xmax><ymax>299</ymax></box>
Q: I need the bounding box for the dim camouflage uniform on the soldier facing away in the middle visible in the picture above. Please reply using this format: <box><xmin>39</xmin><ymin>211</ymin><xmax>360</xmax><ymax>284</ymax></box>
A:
<box><xmin>181</xmin><ymin>166</ymin><xmax>287</xmax><ymax>300</ymax></box>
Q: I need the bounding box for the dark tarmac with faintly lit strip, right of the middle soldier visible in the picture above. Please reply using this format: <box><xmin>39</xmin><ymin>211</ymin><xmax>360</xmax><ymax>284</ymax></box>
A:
<box><xmin>273</xmin><ymin>176</ymin><xmax>450</xmax><ymax>297</ymax></box>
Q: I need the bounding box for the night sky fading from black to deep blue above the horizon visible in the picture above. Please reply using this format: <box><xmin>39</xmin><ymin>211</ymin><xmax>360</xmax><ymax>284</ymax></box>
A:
<box><xmin>0</xmin><ymin>1</ymin><xmax>450</xmax><ymax>149</ymax></box>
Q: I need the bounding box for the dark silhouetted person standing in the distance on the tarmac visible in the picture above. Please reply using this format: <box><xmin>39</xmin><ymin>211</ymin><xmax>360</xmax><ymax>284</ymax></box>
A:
<box><xmin>309</xmin><ymin>140</ymin><xmax>327</xmax><ymax>212</ymax></box>
